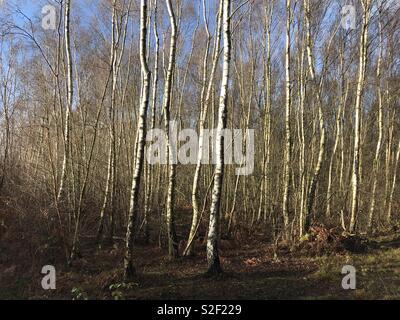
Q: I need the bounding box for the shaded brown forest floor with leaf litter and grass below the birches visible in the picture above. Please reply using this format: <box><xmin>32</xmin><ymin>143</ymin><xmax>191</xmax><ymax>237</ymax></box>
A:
<box><xmin>0</xmin><ymin>212</ymin><xmax>400</xmax><ymax>299</ymax></box>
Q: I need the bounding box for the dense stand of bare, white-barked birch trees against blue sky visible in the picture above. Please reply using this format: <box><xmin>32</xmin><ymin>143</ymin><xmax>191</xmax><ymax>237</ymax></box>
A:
<box><xmin>0</xmin><ymin>0</ymin><xmax>400</xmax><ymax>278</ymax></box>
